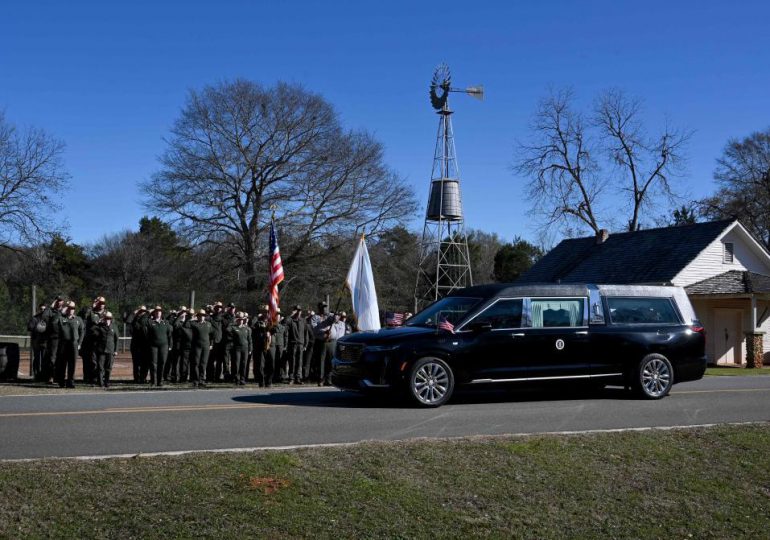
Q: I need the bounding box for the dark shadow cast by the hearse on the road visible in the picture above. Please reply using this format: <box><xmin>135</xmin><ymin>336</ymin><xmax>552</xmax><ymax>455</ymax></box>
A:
<box><xmin>232</xmin><ymin>387</ymin><xmax>635</xmax><ymax>409</ymax></box>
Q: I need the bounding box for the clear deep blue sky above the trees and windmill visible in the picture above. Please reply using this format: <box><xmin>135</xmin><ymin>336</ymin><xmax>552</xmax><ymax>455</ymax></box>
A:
<box><xmin>0</xmin><ymin>0</ymin><xmax>770</xmax><ymax>243</ymax></box>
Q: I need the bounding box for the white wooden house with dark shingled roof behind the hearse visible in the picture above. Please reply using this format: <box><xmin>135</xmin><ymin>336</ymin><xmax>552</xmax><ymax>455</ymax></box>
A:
<box><xmin>519</xmin><ymin>220</ymin><xmax>770</xmax><ymax>366</ymax></box>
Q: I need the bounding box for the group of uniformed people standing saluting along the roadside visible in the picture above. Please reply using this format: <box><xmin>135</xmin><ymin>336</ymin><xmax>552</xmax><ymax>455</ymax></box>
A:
<box><xmin>28</xmin><ymin>296</ymin><xmax>354</xmax><ymax>388</ymax></box>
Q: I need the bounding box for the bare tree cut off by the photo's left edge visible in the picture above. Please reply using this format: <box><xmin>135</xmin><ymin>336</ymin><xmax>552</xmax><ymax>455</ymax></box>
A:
<box><xmin>0</xmin><ymin>111</ymin><xmax>67</xmax><ymax>249</ymax></box>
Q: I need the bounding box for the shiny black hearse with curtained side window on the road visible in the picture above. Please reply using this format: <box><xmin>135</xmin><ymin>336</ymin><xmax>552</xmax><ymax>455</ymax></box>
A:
<box><xmin>332</xmin><ymin>284</ymin><xmax>706</xmax><ymax>407</ymax></box>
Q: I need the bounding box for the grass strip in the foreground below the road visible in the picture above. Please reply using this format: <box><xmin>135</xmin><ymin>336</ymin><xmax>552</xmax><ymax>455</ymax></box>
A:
<box><xmin>0</xmin><ymin>424</ymin><xmax>770</xmax><ymax>539</ymax></box>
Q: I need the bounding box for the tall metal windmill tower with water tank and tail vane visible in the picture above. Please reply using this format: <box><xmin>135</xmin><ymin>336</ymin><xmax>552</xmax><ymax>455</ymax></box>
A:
<box><xmin>414</xmin><ymin>64</ymin><xmax>484</xmax><ymax>311</ymax></box>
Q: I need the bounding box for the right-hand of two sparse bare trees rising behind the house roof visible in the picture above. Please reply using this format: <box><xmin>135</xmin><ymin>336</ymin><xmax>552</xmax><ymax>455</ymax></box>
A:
<box><xmin>594</xmin><ymin>89</ymin><xmax>690</xmax><ymax>231</ymax></box>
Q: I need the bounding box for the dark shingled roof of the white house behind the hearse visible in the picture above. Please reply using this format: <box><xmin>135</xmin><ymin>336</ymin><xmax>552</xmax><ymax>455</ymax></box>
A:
<box><xmin>518</xmin><ymin>220</ymin><xmax>734</xmax><ymax>284</ymax></box>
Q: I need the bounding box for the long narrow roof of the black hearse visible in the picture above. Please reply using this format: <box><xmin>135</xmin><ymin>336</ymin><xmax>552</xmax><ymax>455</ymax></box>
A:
<box><xmin>449</xmin><ymin>283</ymin><xmax>681</xmax><ymax>298</ymax></box>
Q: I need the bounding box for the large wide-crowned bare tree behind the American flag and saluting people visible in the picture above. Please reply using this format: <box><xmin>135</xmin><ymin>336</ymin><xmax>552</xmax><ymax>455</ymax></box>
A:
<box><xmin>142</xmin><ymin>79</ymin><xmax>415</xmax><ymax>290</ymax></box>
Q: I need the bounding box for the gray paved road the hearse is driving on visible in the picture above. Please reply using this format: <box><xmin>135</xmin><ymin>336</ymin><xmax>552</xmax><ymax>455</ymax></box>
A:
<box><xmin>0</xmin><ymin>377</ymin><xmax>770</xmax><ymax>459</ymax></box>
